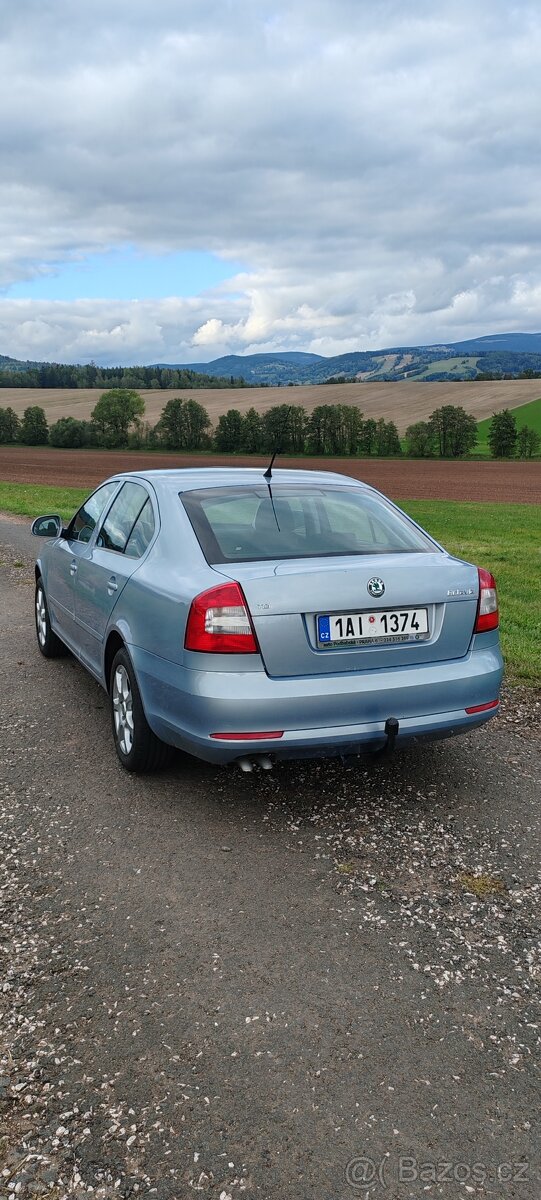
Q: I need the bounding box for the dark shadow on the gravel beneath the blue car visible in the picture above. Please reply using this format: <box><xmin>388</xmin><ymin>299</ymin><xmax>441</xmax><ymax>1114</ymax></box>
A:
<box><xmin>47</xmin><ymin>638</ymin><xmax>525</xmax><ymax>835</ymax></box>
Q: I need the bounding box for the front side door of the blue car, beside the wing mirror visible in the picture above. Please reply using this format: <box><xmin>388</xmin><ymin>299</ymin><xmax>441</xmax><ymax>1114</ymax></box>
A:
<box><xmin>44</xmin><ymin>479</ymin><xmax>120</xmax><ymax>653</ymax></box>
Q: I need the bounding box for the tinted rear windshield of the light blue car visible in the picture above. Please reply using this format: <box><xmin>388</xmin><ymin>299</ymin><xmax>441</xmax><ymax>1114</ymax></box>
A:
<box><xmin>180</xmin><ymin>484</ymin><xmax>434</xmax><ymax>564</ymax></box>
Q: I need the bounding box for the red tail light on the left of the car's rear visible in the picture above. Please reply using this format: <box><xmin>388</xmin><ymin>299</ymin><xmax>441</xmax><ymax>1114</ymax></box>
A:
<box><xmin>184</xmin><ymin>583</ymin><xmax>258</xmax><ymax>654</ymax></box>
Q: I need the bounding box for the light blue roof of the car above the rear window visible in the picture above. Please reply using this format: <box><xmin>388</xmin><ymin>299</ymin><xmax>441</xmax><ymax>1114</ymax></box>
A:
<box><xmin>112</xmin><ymin>467</ymin><xmax>373</xmax><ymax>492</ymax></box>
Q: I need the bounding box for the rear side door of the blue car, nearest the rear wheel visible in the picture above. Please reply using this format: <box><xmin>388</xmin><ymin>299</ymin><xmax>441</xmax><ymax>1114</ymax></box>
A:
<box><xmin>74</xmin><ymin>480</ymin><xmax>155</xmax><ymax>676</ymax></box>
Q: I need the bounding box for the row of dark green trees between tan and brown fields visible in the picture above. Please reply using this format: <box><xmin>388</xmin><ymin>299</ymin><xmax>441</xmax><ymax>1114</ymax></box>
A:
<box><xmin>0</xmin><ymin>388</ymin><xmax>541</xmax><ymax>458</ymax></box>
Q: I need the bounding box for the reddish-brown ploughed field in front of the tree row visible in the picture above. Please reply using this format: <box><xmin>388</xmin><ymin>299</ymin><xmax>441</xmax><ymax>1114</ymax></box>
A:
<box><xmin>0</xmin><ymin>446</ymin><xmax>541</xmax><ymax>504</ymax></box>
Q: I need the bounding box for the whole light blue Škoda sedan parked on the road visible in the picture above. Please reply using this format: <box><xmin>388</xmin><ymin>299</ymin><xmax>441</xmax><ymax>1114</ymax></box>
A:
<box><xmin>32</xmin><ymin>468</ymin><xmax>503</xmax><ymax>772</ymax></box>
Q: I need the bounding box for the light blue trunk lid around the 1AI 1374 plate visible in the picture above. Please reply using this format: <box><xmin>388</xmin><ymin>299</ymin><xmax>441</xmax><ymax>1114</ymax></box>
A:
<box><xmin>216</xmin><ymin>551</ymin><xmax>479</xmax><ymax>678</ymax></box>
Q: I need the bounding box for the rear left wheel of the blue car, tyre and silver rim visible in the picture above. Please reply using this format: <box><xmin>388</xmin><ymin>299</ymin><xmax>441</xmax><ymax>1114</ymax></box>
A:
<box><xmin>109</xmin><ymin>649</ymin><xmax>173</xmax><ymax>773</ymax></box>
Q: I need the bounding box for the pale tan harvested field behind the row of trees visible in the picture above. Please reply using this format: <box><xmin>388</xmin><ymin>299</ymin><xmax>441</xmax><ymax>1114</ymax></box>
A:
<box><xmin>0</xmin><ymin>379</ymin><xmax>541</xmax><ymax>434</ymax></box>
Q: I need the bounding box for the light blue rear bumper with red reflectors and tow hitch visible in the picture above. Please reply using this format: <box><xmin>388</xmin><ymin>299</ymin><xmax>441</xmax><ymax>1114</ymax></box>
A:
<box><xmin>130</xmin><ymin>634</ymin><xmax>503</xmax><ymax>763</ymax></box>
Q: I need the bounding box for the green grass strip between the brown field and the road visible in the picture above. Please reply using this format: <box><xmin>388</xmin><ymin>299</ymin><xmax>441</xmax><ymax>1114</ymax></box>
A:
<box><xmin>0</xmin><ymin>482</ymin><xmax>541</xmax><ymax>686</ymax></box>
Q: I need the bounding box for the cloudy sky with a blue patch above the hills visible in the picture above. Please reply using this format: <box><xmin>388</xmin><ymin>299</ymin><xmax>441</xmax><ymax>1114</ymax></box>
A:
<box><xmin>0</xmin><ymin>0</ymin><xmax>541</xmax><ymax>365</ymax></box>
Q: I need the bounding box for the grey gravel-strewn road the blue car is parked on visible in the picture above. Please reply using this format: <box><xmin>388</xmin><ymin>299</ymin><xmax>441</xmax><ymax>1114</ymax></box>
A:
<box><xmin>0</xmin><ymin>521</ymin><xmax>541</xmax><ymax>1200</ymax></box>
